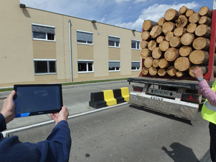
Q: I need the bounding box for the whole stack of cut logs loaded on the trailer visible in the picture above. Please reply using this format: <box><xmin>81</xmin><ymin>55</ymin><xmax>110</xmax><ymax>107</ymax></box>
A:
<box><xmin>141</xmin><ymin>6</ymin><xmax>216</xmax><ymax>77</ymax></box>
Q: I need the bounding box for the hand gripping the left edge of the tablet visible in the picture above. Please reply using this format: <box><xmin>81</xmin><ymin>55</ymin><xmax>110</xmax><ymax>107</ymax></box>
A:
<box><xmin>1</xmin><ymin>90</ymin><xmax>16</xmax><ymax>124</ymax></box>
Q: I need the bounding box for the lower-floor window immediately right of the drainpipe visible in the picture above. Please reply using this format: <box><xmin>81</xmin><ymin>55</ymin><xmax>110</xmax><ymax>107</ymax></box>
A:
<box><xmin>78</xmin><ymin>60</ymin><xmax>94</xmax><ymax>73</ymax></box>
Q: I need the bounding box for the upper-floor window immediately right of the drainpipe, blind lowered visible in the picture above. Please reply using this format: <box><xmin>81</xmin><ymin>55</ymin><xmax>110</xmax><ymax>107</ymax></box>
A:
<box><xmin>77</xmin><ymin>31</ymin><xmax>93</xmax><ymax>44</ymax></box>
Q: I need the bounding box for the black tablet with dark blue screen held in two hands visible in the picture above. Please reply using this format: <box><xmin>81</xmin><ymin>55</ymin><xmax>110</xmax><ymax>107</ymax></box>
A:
<box><xmin>14</xmin><ymin>84</ymin><xmax>63</xmax><ymax>117</ymax></box>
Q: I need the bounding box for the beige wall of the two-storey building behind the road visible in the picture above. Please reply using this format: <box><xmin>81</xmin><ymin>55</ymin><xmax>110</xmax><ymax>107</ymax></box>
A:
<box><xmin>0</xmin><ymin>0</ymin><xmax>141</xmax><ymax>87</ymax></box>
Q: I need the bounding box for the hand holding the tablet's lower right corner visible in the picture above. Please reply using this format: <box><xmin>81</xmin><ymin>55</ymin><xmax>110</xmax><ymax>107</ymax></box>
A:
<box><xmin>50</xmin><ymin>106</ymin><xmax>69</xmax><ymax>124</ymax></box>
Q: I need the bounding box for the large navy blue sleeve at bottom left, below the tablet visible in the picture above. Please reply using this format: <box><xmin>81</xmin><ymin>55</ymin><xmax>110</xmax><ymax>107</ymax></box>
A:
<box><xmin>0</xmin><ymin>121</ymin><xmax>71</xmax><ymax>162</ymax></box>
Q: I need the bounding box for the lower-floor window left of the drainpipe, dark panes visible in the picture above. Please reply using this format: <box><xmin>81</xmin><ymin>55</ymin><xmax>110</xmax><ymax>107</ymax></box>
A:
<box><xmin>34</xmin><ymin>59</ymin><xmax>56</xmax><ymax>74</ymax></box>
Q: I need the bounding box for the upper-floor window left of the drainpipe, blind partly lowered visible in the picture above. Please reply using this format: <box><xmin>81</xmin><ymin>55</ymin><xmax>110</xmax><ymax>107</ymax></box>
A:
<box><xmin>32</xmin><ymin>24</ymin><xmax>55</xmax><ymax>41</ymax></box>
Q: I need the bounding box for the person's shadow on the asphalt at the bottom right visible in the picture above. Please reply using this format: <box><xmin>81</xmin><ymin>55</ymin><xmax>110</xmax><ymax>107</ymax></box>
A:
<box><xmin>162</xmin><ymin>142</ymin><xmax>199</xmax><ymax>162</ymax></box>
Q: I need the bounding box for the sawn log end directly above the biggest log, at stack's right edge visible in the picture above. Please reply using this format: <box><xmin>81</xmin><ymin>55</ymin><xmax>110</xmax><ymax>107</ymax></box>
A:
<box><xmin>193</xmin><ymin>37</ymin><xmax>210</xmax><ymax>51</ymax></box>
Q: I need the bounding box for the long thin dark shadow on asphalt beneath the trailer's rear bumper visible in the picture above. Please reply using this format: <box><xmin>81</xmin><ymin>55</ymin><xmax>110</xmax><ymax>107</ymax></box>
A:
<box><xmin>129</xmin><ymin>105</ymin><xmax>193</xmax><ymax>126</ymax></box>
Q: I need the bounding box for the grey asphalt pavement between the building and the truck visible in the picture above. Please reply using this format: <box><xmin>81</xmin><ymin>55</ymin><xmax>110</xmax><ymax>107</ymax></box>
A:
<box><xmin>0</xmin><ymin>81</ymin><xmax>209</xmax><ymax>162</ymax></box>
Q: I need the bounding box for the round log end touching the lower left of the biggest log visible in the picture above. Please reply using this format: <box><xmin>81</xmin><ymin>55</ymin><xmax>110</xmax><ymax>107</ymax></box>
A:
<box><xmin>174</xmin><ymin>57</ymin><xmax>190</xmax><ymax>71</ymax></box>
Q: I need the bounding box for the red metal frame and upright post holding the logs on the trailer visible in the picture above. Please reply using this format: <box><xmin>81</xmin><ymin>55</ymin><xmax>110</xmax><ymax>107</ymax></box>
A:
<box><xmin>140</xmin><ymin>10</ymin><xmax>216</xmax><ymax>81</ymax></box>
